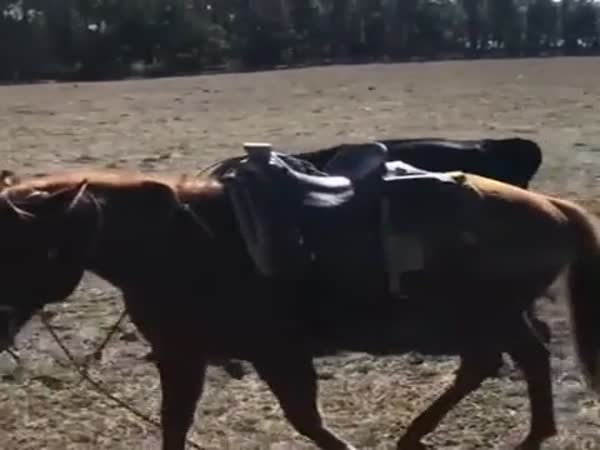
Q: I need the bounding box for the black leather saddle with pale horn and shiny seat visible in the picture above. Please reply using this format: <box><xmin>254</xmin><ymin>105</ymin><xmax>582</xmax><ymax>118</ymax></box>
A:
<box><xmin>221</xmin><ymin>142</ymin><xmax>464</xmax><ymax>277</ymax></box>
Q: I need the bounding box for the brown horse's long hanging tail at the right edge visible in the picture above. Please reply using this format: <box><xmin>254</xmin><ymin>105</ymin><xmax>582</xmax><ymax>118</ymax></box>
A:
<box><xmin>550</xmin><ymin>198</ymin><xmax>600</xmax><ymax>393</ymax></box>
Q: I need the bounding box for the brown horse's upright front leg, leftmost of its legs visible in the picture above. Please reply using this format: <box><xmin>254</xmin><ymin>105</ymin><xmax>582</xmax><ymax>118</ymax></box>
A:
<box><xmin>156</xmin><ymin>347</ymin><xmax>206</xmax><ymax>450</ymax></box>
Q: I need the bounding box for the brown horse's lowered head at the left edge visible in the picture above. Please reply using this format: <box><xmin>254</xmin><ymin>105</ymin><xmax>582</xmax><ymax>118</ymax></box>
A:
<box><xmin>0</xmin><ymin>180</ymin><xmax>99</xmax><ymax>351</ymax></box>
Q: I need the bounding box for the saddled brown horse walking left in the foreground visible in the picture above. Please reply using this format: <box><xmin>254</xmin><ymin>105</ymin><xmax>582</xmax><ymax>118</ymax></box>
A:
<box><xmin>0</xmin><ymin>172</ymin><xmax>600</xmax><ymax>450</ymax></box>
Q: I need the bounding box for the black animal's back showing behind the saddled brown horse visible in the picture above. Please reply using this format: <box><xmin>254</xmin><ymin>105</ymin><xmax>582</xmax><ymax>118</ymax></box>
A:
<box><xmin>213</xmin><ymin>138</ymin><xmax>542</xmax><ymax>188</ymax></box>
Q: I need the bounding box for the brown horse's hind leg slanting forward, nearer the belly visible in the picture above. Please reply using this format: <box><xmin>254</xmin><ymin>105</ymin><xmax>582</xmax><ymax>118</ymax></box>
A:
<box><xmin>396</xmin><ymin>352</ymin><xmax>503</xmax><ymax>450</ymax></box>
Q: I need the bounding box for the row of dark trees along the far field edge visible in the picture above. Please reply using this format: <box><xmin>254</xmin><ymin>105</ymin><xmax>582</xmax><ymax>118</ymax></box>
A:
<box><xmin>0</xmin><ymin>0</ymin><xmax>600</xmax><ymax>81</ymax></box>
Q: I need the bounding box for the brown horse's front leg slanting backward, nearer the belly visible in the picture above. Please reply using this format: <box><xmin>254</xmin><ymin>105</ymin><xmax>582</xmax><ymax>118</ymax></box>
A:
<box><xmin>253</xmin><ymin>355</ymin><xmax>353</xmax><ymax>450</ymax></box>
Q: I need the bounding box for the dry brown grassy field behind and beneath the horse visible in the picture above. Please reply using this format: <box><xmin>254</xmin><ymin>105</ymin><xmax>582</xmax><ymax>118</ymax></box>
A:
<box><xmin>0</xmin><ymin>58</ymin><xmax>600</xmax><ymax>450</ymax></box>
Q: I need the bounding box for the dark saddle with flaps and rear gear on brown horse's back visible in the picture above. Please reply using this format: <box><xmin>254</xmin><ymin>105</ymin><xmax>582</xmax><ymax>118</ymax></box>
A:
<box><xmin>221</xmin><ymin>142</ymin><xmax>474</xmax><ymax>292</ymax></box>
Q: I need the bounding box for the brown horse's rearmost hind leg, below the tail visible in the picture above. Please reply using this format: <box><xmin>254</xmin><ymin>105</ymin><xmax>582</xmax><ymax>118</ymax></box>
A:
<box><xmin>508</xmin><ymin>314</ymin><xmax>556</xmax><ymax>450</ymax></box>
